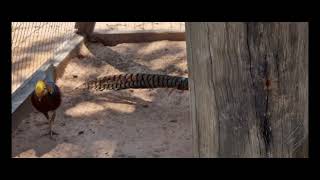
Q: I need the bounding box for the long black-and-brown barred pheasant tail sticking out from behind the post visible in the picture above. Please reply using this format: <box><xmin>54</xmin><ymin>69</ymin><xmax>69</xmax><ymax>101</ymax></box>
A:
<box><xmin>78</xmin><ymin>73</ymin><xmax>188</xmax><ymax>91</ymax></box>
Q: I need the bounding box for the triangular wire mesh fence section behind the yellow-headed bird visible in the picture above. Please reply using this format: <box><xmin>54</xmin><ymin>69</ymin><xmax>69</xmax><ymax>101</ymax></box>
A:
<box><xmin>11</xmin><ymin>22</ymin><xmax>74</xmax><ymax>93</ymax></box>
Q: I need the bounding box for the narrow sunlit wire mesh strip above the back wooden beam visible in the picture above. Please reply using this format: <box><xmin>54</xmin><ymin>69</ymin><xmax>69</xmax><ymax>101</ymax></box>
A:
<box><xmin>95</xmin><ymin>22</ymin><xmax>185</xmax><ymax>32</ymax></box>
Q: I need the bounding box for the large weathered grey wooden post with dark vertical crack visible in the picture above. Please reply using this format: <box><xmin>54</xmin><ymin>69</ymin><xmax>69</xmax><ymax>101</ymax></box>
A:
<box><xmin>186</xmin><ymin>22</ymin><xmax>308</xmax><ymax>157</ymax></box>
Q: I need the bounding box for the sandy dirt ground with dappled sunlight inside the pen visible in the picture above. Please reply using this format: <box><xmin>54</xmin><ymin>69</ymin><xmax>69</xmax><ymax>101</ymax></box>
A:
<box><xmin>12</xmin><ymin>41</ymin><xmax>192</xmax><ymax>158</ymax></box>
